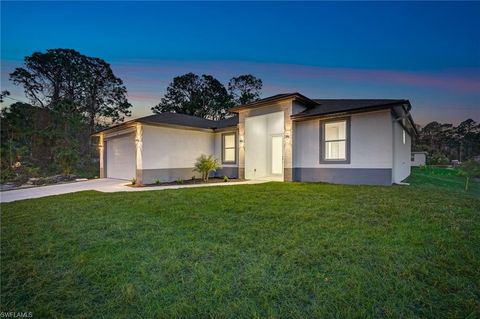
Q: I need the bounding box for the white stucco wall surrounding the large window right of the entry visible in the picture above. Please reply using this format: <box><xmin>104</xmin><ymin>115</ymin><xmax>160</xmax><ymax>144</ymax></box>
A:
<box><xmin>293</xmin><ymin>111</ymin><xmax>393</xmax><ymax>169</ymax></box>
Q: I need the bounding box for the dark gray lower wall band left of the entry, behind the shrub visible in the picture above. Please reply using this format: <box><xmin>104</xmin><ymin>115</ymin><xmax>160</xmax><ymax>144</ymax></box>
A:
<box><xmin>137</xmin><ymin>167</ymin><xmax>238</xmax><ymax>184</ymax></box>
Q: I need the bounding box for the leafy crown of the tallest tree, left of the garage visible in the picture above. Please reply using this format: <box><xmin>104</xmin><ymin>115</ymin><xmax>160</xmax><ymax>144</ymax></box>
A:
<box><xmin>10</xmin><ymin>49</ymin><xmax>131</xmax><ymax>133</ymax></box>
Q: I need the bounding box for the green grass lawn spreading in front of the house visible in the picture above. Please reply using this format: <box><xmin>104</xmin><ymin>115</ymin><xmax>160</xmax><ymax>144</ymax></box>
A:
<box><xmin>0</xmin><ymin>170</ymin><xmax>480</xmax><ymax>318</ymax></box>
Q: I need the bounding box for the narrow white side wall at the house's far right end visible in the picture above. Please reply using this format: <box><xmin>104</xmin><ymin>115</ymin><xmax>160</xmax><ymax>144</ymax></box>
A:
<box><xmin>392</xmin><ymin>117</ymin><xmax>412</xmax><ymax>183</ymax></box>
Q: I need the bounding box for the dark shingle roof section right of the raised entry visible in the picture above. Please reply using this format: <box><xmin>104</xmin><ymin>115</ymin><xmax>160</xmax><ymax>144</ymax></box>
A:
<box><xmin>292</xmin><ymin>99</ymin><xmax>409</xmax><ymax>118</ymax></box>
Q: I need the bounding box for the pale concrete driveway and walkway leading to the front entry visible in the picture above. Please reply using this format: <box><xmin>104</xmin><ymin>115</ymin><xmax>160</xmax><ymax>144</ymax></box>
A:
<box><xmin>0</xmin><ymin>178</ymin><xmax>265</xmax><ymax>203</ymax></box>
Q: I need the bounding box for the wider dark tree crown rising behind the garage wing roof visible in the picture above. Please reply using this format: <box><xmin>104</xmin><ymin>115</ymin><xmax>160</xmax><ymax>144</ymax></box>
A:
<box><xmin>152</xmin><ymin>73</ymin><xmax>233</xmax><ymax>120</ymax></box>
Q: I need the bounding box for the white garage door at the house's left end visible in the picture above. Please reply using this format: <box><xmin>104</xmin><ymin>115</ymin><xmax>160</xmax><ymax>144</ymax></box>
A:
<box><xmin>107</xmin><ymin>134</ymin><xmax>135</xmax><ymax>180</ymax></box>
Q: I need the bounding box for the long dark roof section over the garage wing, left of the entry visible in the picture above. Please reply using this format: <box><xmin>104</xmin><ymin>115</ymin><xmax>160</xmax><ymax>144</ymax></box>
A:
<box><xmin>94</xmin><ymin>113</ymin><xmax>238</xmax><ymax>135</ymax></box>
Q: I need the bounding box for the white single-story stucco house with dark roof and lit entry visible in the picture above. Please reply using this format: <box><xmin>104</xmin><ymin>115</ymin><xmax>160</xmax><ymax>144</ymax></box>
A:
<box><xmin>95</xmin><ymin>93</ymin><xmax>417</xmax><ymax>185</ymax></box>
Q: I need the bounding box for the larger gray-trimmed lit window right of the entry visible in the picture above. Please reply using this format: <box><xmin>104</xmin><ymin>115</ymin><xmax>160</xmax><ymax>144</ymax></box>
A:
<box><xmin>320</xmin><ymin>118</ymin><xmax>350</xmax><ymax>164</ymax></box>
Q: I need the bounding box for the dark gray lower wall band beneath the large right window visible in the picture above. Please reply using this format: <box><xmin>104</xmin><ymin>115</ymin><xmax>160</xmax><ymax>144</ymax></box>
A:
<box><xmin>293</xmin><ymin>167</ymin><xmax>392</xmax><ymax>185</ymax></box>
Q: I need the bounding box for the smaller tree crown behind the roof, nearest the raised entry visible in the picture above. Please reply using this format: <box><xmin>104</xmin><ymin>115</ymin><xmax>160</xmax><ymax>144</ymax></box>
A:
<box><xmin>228</xmin><ymin>74</ymin><xmax>263</xmax><ymax>105</ymax></box>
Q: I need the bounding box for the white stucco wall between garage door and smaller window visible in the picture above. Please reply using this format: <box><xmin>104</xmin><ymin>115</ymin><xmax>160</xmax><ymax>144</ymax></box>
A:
<box><xmin>142</xmin><ymin>125</ymin><xmax>215</xmax><ymax>169</ymax></box>
